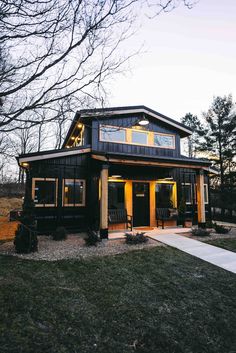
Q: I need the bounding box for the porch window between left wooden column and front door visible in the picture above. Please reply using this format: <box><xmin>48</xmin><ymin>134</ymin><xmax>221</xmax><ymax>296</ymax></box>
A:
<box><xmin>108</xmin><ymin>182</ymin><xmax>125</xmax><ymax>209</ymax></box>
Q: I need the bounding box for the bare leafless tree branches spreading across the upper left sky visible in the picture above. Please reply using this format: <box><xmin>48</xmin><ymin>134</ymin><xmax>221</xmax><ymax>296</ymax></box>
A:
<box><xmin>0</xmin><ymin>0</ymin><xmax>195</xmax><ymax>131</ymax></box>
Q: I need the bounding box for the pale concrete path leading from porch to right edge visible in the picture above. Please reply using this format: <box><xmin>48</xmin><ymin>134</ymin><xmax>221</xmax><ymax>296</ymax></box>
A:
<box><xmin>148</xmin><ymin>233</ymin><xmax>236</xmax><ymax>273</ymax></box>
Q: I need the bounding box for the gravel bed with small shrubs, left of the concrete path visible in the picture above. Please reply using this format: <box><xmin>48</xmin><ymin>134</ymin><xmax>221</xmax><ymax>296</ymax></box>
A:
<box><xmin>0</xmin><ymin>235</ymin><xmax>162</xmax><ymax>261</ymax></box>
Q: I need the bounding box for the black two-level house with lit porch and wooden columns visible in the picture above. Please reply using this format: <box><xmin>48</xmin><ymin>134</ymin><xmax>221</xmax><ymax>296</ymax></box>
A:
<box><xmin>18</xmin><ymin>106</ymin><xmax>211</xmax><ymax>236</ymax></box>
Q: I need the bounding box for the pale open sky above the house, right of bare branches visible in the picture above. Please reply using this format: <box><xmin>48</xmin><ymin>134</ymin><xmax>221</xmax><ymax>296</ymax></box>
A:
<box><xmin>106</xmin><ymin>0</ymin><xmax>236</xmax><ymax>120</ymax></box>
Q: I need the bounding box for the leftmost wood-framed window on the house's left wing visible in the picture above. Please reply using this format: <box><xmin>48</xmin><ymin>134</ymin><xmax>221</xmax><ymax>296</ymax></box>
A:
<box><xmin>32</xmin><ymin>178</ymin><xmax>57</xmax><ymax>207</ymax></box>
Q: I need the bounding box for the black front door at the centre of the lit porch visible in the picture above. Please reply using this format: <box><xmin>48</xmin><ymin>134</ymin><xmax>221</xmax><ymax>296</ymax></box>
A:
<box><xmin>133</xmin><ymin>182</ymin><xmax>150</xmax><ymax>227</ymax></box>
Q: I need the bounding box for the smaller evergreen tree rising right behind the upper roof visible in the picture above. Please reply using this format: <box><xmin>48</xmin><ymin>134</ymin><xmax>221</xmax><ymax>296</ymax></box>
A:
<box><xmin>181</xmin><ymin>113</ymin><xmax>204</xmax><ymax>158</ymax></box>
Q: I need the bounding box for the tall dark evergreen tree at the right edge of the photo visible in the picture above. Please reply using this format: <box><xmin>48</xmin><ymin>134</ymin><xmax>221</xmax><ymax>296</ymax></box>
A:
<box><xmin>199</xmin><ymin>95</ymin><xmax>236</xmax><ymax>214</ymax></box>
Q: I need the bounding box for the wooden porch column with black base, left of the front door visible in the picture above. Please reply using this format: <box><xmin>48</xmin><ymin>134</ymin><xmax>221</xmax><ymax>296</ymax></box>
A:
<box><xmin>100</xmin><ymin>164</ymin><xmax>108</xmax><ymax>239</ymax></box>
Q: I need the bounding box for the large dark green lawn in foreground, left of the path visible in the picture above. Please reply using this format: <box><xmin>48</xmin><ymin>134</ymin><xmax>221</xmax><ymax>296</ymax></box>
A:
<box><xmin>0</xmin><ymin>247</ymin><xmax>236</xmax><ymax>353</ymax></box>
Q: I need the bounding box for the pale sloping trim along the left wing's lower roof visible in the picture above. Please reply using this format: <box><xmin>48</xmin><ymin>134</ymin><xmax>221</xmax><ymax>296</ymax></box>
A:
<box><xmin>18</xmin><ymin>148</ymin><xmax>91</xmax><ymax>164</ymax></box>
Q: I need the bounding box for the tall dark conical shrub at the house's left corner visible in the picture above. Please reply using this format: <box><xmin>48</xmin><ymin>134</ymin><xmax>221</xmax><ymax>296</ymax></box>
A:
<box><xmin>14</xmin><ymin>197</ymin><xmax>38</xmax><ymax>254</ymax></box>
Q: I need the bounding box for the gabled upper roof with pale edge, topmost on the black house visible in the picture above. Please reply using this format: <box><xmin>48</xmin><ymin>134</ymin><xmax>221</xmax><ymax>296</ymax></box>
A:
<box><xmin>62</xmin><ymin>105</ymin><xmax>192</xmax><ymax>148</ymax></box>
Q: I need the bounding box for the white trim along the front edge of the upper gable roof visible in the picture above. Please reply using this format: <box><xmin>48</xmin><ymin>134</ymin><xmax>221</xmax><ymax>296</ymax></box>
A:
<box><xmin>81</xmin><ymin>108</ymin><xmax>192</xmax><ymax>135</ymax></box>
